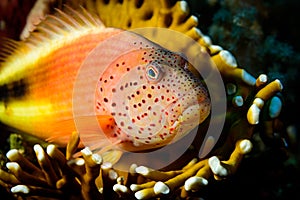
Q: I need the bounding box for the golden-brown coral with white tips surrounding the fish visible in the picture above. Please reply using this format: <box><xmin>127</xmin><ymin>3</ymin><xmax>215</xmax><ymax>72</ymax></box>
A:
<box><xmin>0</xmin><ymin>0</ymin><xmax>298</xmax><ymax>199</ymax></box>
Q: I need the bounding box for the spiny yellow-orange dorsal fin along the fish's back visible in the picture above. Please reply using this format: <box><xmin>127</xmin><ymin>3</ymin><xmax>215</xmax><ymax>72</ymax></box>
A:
<box><xmin>0</xmin><ymin>6</ymin><xmax>105</xmax><ymax>85</ymax></box>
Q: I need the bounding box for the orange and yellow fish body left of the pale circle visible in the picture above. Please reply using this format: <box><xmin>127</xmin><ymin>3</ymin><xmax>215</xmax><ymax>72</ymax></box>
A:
<box><xmin>0</xmin><ymin>8</ymin><xmax>120</xmax><ymax>145</ymax></box>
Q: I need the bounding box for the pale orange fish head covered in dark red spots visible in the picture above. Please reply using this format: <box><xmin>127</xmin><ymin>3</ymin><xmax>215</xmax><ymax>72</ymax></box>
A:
<box><xmin>95</xmin><ymin>46</ymin><xmax>210</xmax><ymax>151</ymax></box>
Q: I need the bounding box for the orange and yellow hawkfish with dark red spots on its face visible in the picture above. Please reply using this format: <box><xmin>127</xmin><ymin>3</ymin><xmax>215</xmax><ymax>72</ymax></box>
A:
<box><xmin>0</xmin><ymin>7</ymin><xmax>210</xmax><ymax>158</ymax></box>
